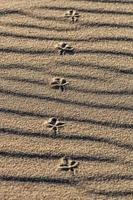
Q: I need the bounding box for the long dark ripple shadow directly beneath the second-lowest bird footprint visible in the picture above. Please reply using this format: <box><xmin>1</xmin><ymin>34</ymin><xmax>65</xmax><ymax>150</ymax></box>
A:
<box><xmin>0</xmin><ymin>125</ymin><xmax>133</xmax><ymax>151</ymax></box>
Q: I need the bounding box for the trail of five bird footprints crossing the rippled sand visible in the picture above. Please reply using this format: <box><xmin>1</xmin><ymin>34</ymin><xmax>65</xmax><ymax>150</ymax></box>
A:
<box><xmin>44</xmin><ymin>10</ymin><xmax>80</xmax><ymax>176</ymax></box>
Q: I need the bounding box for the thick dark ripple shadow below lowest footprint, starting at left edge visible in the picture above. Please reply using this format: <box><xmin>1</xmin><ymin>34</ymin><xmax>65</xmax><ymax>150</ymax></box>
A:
<box><xmin>0</xmin><ymin>175</ymin><xmax>77</xmax><ymax>185</ymax></box>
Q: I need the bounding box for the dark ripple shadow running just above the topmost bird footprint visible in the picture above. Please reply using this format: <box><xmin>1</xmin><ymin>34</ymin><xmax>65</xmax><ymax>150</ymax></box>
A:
<box><xmin>37</xmin><ymin>6</ymin><xmax>133</xmax><ymax>16</ymax></box>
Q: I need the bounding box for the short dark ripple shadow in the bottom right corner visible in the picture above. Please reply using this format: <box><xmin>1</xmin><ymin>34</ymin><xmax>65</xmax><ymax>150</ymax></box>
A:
<box><xmin>90</xmin><ymin>190</ymin><xmax>133</xmax><ymax>197</ymax></box>
